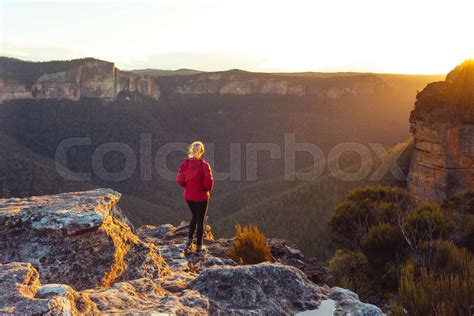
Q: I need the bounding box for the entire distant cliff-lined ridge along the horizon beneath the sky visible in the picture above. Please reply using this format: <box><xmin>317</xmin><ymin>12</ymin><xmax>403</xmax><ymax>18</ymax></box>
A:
<box><xmin>0</xmin><ymin>57</ymin><xmax>442</xmax><ymax>102</ymax></box>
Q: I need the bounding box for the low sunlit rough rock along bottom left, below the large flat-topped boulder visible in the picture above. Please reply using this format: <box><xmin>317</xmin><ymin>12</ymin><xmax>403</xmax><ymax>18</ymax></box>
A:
<box><xmin>0</xmin><ymin>262</ymin><xmax>209</xmax><ymax>315</ymax></box>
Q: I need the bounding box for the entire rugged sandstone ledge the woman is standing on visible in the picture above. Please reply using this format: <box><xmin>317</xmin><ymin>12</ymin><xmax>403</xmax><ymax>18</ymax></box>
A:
<box><xmin>0</xmin><ymin>189</ymin><xmax>382</xmax><ymax>315</ymax></box>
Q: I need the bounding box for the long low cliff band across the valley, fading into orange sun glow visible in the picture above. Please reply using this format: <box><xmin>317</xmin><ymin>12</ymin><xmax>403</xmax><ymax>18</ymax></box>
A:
<box><xmin>158</xmin><ymin>70</ymin><xmax>388</xmax><ymax>99</ymax></box>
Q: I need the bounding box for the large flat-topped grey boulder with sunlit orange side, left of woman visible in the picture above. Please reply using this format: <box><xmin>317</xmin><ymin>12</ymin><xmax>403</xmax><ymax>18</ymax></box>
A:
<box><xmin>0</xmin><ymin>189</ymin><xmax>168</xmax><ymax>290</ymax></box>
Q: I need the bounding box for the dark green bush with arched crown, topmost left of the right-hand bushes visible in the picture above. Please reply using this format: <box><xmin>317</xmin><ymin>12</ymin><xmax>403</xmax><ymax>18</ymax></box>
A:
<box><xmin>329</xmin><ymin>186</ymin><xmax>411</xmax><ymax>250</ymax></box>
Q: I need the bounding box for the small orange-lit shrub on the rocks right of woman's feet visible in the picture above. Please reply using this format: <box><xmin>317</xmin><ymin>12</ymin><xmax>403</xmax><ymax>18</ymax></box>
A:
<box><xmin>229</xmin><ymin>224</ymin><xmax>272</xmax><ymax>264</ymax></box>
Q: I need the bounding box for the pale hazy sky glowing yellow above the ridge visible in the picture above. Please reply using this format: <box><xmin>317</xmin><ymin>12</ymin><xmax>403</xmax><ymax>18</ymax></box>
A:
<box><xmin>0</xmin><ymin>0</ymin><xmax>474</xmax><ymax>73</ymax></box>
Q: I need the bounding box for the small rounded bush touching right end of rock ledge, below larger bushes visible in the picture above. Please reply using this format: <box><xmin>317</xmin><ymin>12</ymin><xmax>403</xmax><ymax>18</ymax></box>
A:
<box><xmin>328</xmin><ymin>249</ymin><xmax>373</xmax><ymax>296</ymax></box>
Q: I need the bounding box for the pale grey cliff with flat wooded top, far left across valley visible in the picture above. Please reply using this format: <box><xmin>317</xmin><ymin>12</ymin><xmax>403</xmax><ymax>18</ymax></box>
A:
<box><xmin>0</xmin><ymin>58</ymin><xmax>160</xmax><ymax>102</ymax></box>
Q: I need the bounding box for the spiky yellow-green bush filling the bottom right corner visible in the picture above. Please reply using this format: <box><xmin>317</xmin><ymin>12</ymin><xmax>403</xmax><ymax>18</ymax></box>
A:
<box><xmin>399</xmin><ymin>241</ymin><xmax>474</xmax><ymax>316</ymax></box>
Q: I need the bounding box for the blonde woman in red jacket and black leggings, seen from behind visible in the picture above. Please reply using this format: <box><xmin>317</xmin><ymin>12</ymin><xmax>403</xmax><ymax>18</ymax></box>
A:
<box><xmin>176</xmin><ymin>141</ymin><xmax>214</xmax><ymax>252</ymax></box>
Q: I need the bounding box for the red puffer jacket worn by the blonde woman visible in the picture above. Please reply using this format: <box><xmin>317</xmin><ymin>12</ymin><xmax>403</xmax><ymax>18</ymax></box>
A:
<box><xmin>176</xmin><ymin>158</ymin><xmax>214</xmax><ymax>202</ymax></box>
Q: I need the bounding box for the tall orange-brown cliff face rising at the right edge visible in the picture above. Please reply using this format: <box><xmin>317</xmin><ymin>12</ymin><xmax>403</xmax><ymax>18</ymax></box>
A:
<box><xmin>408</xmin><ymin>60</ymin><xmax>474</xmax><ymax>202</ymax></box>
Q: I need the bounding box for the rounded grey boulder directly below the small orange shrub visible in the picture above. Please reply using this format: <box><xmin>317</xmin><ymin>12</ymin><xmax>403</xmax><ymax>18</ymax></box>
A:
<box><xmin>189</xmin><ymin>263</ymin><xmax>326</xmax><ymax>315</ymax></box>
